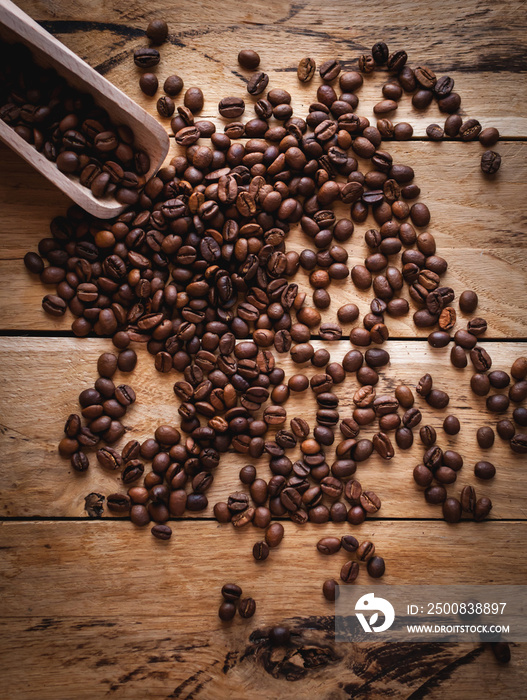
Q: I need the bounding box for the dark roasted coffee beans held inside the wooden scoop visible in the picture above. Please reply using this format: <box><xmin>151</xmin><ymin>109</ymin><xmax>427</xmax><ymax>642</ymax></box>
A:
<box><xmin>0</xmin><ymin>41</ymin><xmax>150</xmax><ymax>202</ymax></box>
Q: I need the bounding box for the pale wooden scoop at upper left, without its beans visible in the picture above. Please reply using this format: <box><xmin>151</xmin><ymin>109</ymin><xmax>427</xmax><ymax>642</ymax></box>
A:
<box><xmin>0</xmin><ymin>0</ymin><xmax>169</xmax><ymax>219</ymax></box>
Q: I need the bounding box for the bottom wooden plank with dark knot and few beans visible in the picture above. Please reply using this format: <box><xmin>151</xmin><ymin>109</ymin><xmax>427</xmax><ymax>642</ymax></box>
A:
<box><xmin>0</xmin><ymin>522</ymin><xmax>527</xmax><ymax>700</ymax></box>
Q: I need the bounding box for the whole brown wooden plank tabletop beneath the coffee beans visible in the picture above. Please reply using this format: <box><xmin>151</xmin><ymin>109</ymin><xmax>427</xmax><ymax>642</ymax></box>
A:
<box><xmin>0</xmin><ymin>0</ymin><xmax>527</xmax><ymax>700</ymax></box>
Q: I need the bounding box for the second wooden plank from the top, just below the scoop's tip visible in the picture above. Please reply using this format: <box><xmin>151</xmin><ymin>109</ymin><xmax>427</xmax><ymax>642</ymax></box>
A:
<box><xmin>0</xmin><ymin>142</ymin><xmax>527</xmax><ymax>338</ymax></box>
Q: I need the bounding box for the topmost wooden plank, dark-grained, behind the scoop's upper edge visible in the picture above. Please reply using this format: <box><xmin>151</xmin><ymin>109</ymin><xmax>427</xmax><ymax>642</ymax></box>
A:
<box><xmin>14</xmin><ymin>0</ymin><xmax>527</xmax><ymax>137</ymax></box>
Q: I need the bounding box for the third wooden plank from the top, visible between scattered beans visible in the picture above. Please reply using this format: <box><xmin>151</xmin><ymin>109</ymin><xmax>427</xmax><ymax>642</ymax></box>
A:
<box><xmin>0</xmin><ymin>337</ymin><xmax>527</xmax><ymax>519</ymax></box>
